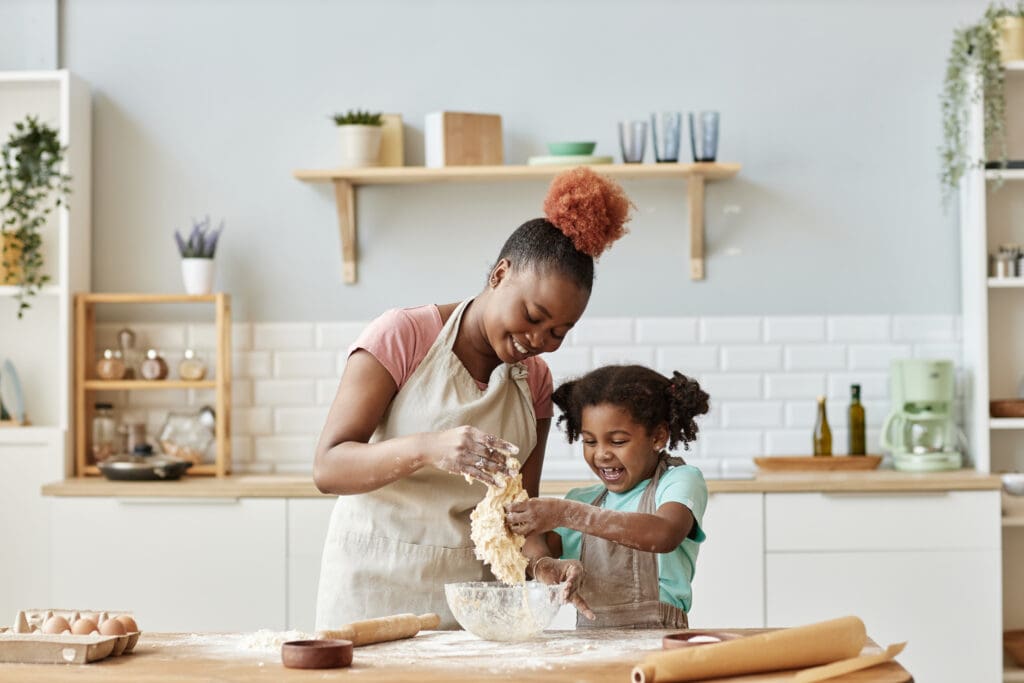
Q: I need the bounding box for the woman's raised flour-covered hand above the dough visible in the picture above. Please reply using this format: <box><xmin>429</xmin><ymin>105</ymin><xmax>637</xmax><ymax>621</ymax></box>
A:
<box><xmin>423</xmin><ymin>425</ymin><xmax>519</xmax><ymax>484</ymax></box>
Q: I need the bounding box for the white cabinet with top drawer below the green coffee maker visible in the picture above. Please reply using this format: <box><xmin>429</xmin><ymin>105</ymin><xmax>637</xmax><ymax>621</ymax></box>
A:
<box><xmin>765</xmin><ymin>490</ymin><xmax>1001</xmax><ymax>683</ymax></box>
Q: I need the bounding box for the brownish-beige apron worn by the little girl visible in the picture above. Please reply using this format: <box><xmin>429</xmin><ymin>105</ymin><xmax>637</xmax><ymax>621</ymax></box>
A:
<box><xmin>577</xmin><ymin>452</ymin><xmax>689</xmax><ymax>629</ymax></box>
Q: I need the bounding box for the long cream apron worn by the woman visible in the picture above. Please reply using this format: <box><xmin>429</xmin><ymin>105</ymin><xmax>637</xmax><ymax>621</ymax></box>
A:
<box><xmin>316</xmin><ymin>299</ymin><xmax>537</xmax><ymax>630</ymax></box>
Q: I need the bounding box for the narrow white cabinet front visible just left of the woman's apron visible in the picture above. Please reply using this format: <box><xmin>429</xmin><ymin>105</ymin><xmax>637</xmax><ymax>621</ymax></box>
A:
<box><xmin>288</xmin><ymin>496</ymin><xmax>337</xmax><ymax>633</ymax></box>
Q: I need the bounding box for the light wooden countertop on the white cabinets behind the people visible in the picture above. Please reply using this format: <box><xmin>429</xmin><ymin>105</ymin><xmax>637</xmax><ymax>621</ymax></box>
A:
<box><xmin>42</xmin><ymin>470</ymin><xmax>1001</xmax><ymax>499</ymax></box>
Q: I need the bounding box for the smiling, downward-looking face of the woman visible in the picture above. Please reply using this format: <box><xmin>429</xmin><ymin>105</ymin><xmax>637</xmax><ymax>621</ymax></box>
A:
<box><xmin>483</xmin><ymin>260</ymin><xmax>590</xmax><ymax>362</ymax></box>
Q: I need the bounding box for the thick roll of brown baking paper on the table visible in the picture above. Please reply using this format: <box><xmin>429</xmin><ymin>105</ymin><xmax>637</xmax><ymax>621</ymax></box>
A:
<box><xmin>632</xmin><ymin>616</ymin><xmax>867</xmax><ymax>683</ymax></box>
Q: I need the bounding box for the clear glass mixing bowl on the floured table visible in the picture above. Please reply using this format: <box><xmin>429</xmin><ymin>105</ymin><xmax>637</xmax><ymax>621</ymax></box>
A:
<box><xmin>444</xmin><ymin>581</ymin><xmax>565</xmax><ymax>640</ymax></box>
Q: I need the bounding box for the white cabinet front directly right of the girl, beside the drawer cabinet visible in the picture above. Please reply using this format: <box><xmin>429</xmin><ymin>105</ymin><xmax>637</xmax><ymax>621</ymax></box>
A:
<box><xmin>689</xmin><ymin>494</ymin><xmax>765</xmax><ymax>629</ymax></box>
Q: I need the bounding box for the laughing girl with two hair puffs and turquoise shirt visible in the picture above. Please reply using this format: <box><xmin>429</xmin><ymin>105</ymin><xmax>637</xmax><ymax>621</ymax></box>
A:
<box><xmin>507</xmin><ymin>366</ymin><xmax>708</xmax><ymax>629</ymax></box>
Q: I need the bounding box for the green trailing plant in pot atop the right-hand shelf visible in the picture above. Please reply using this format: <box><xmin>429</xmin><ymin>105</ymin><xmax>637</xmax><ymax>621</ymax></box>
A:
<box><xmin>940</xmin><ymin>2</ymin><xmax>1024</xmax><ymax>199</ymax></box>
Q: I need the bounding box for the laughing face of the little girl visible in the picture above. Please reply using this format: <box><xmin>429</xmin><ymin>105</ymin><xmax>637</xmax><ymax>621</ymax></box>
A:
<box><xmin>580</xmin><ymin>403</ymin><xmax>669</xmax><ymax>494</ymax></box>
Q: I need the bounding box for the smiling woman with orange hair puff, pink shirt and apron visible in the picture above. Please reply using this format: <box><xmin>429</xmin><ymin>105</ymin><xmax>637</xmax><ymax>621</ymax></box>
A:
<box><xmin>313</xmin><ymin>168</ymin><xmax>630</xmax><ymax>630</ymax></box>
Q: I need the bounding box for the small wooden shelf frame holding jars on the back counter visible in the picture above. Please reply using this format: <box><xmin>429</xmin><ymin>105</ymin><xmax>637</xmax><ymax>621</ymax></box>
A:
<box><xmin>74</xmin><ymin>293</ymin><xmax>231</xmax><ymax>477</ymax></box>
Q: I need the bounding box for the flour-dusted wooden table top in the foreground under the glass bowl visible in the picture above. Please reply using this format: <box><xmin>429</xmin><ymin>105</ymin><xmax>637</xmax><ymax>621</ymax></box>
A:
<box><xmin>0</xmin><ymin>629</ymin><xmax>911</xmax><ymax>683</ymax></box>
